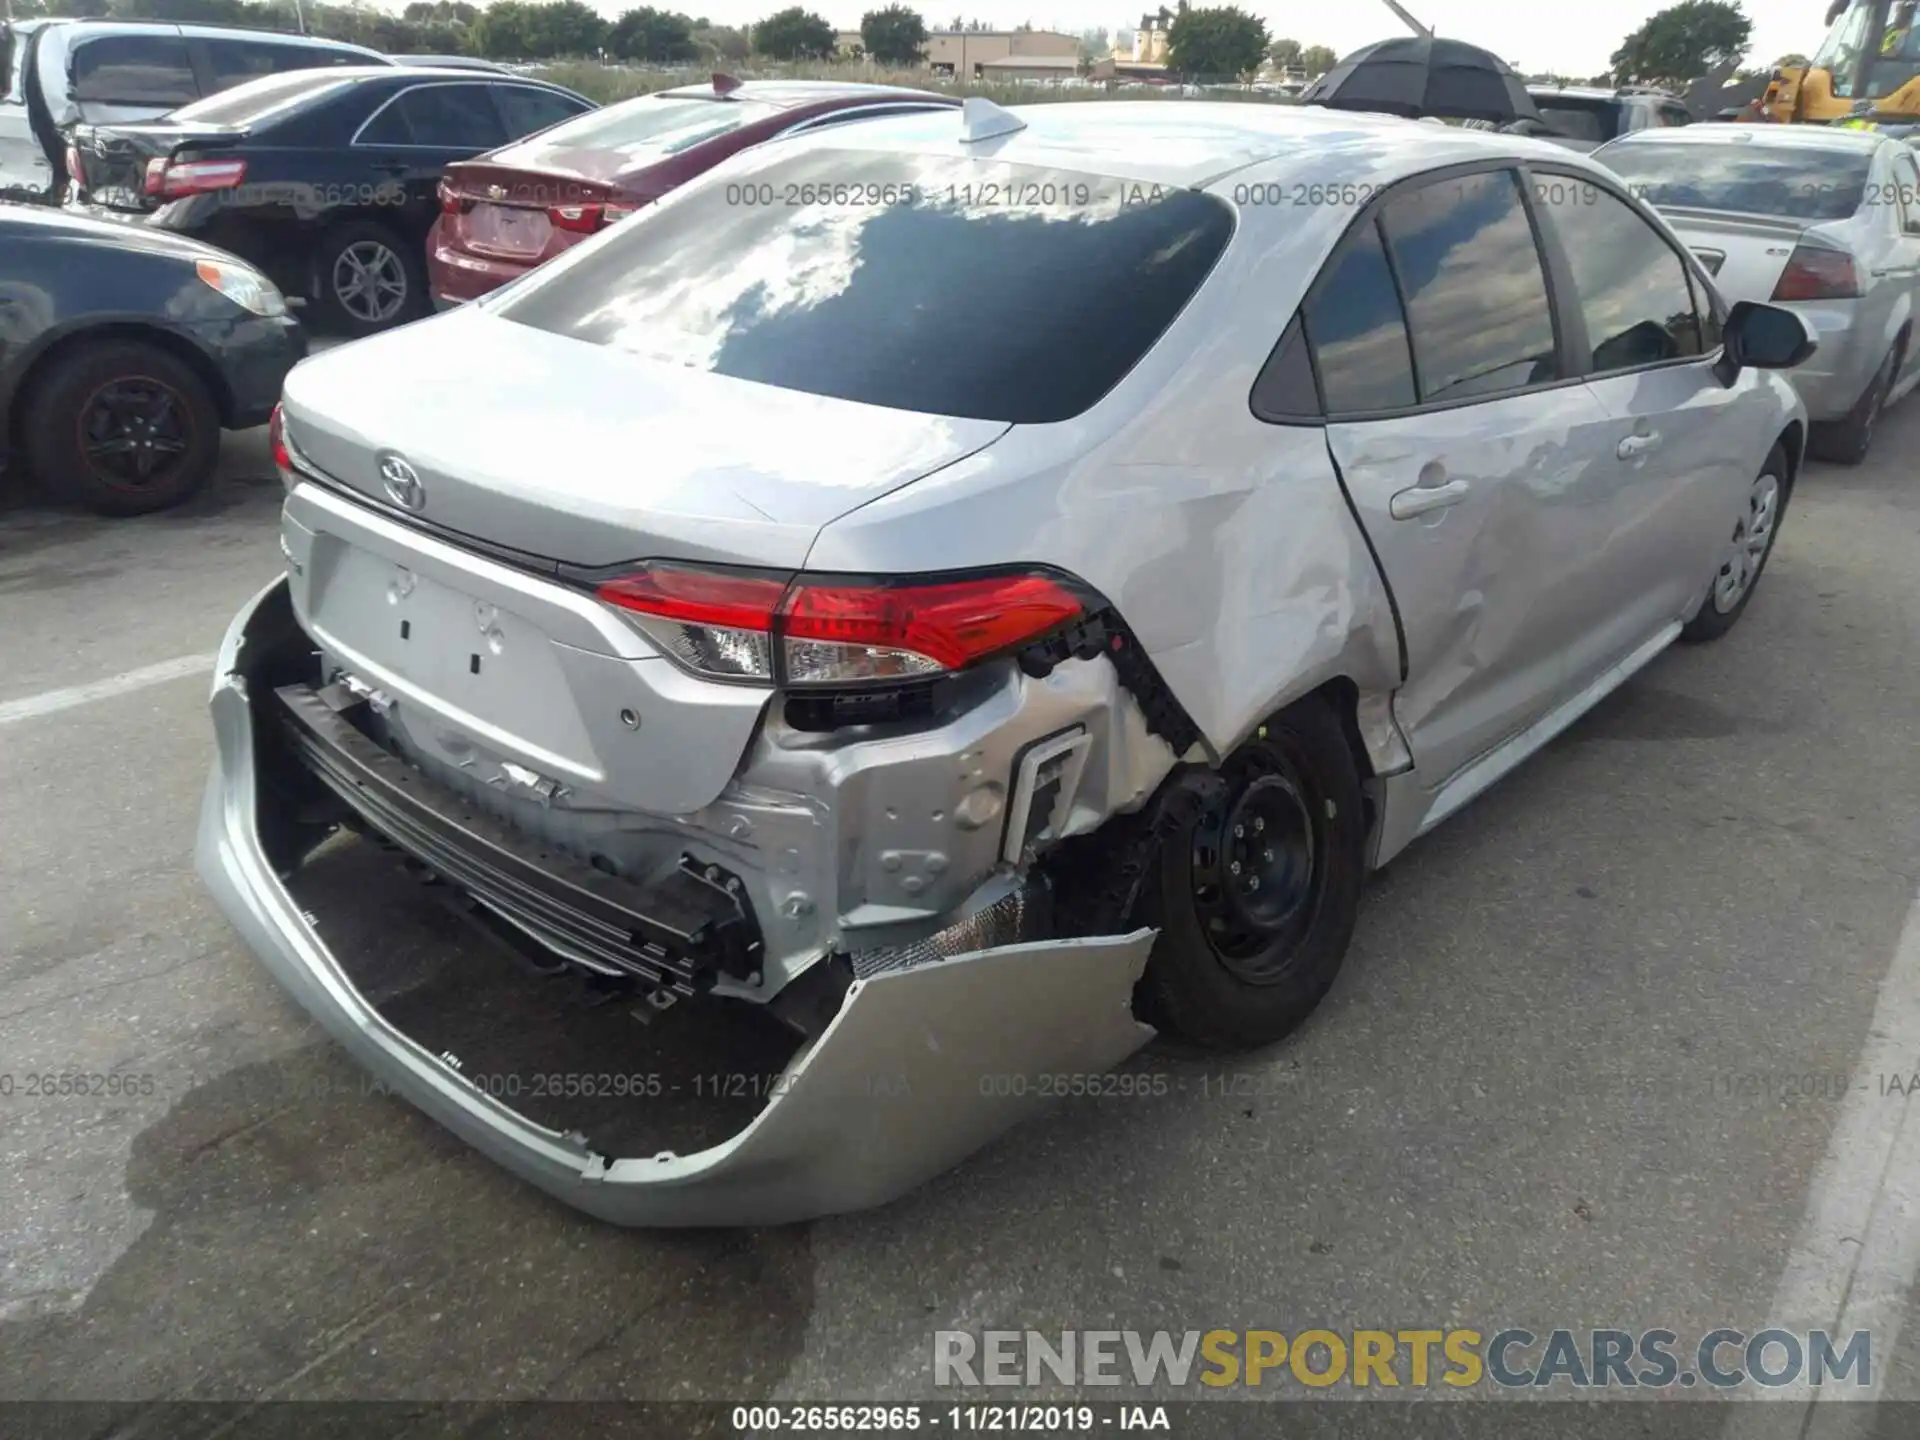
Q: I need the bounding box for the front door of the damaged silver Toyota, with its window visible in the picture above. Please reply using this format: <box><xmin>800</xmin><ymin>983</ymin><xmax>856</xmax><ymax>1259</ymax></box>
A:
<box><xmin>1532</xmin><ymin>171</ymin><xmax>1764</xmax><ymax>664</ymax></box>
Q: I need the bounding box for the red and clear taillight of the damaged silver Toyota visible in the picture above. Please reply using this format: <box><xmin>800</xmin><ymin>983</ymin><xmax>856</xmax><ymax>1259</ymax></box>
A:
<box><xmin>595</xmin><ymin>564</ymin><xmax>1087</xmax><ymax>687</ymax></box>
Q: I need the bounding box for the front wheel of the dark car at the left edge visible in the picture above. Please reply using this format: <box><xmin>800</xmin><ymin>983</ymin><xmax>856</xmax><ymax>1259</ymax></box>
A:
<box><xmin>21</xmin><ymin>340</ymin><xmax>221</xmax><ymax>515</ymax></box>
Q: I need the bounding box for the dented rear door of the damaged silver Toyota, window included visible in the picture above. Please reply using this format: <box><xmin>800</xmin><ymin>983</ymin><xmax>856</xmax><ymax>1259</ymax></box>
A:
<box><xmin>1304</xmin><ymin>167</ymin><xmax>1613</xmax><ymax>802</ymax></box>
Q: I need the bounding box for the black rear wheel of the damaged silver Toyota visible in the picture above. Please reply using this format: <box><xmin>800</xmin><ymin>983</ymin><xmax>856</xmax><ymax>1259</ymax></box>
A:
<box><xmin>1137</xmin><ymin>699</ymin><xmax>1367</xmax><ymax>1050</ymax></box>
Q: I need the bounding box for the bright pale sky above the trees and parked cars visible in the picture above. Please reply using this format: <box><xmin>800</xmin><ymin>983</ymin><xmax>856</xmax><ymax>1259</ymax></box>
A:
<box><xmin>480</xmin><ymin>0</ymin><xmax>1826</xmax><ymax>77</ymax></box>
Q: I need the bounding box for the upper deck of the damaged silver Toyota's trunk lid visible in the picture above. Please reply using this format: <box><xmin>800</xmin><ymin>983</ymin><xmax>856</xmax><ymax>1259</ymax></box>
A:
<box><xmin>286</xmin><ymin>301</ymin><xmax>1012</xmax><ymax>568</ymax></box>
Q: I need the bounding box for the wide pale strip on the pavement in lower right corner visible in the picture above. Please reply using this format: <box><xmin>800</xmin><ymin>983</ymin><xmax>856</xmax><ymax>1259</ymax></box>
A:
<box><xmin>1726</xmin><ymin>899</ymin><xmax>1920</xmax><ymax>1440</ymax></box>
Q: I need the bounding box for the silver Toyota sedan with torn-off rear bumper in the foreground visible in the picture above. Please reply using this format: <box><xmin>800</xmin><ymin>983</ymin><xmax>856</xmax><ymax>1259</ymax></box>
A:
<box><xmin>200</xmin><ymin>100</ymin><xmax>1809</xmax><ymax>1225</ymax></box>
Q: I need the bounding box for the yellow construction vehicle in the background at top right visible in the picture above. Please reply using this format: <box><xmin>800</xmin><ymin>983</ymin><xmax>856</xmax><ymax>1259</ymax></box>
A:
<box><xmin>1759</xmin><ymin>0</ymin><xmax>1920</xmax><ymax>127</ymax></box>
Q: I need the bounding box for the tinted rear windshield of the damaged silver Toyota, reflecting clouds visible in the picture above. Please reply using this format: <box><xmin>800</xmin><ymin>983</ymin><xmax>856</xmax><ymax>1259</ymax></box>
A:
<box><xmin>497</xmin><ymin>150</ymin><xmax>1233</xmax><ymax>424</ymax></box>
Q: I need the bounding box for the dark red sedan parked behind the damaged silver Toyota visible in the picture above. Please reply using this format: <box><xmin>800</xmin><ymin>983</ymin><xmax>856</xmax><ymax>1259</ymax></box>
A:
<box><xmin>426</xmin><ymin>75</ymin><xmax>960</xmax><ymax>305</ymax></box>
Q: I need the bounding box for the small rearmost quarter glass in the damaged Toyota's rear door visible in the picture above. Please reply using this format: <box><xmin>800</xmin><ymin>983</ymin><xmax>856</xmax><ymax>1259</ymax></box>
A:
<box><xmin>1306</xmin><ymin>221</ymin><xmax>1417</xmax><ymax>415</ymax></box>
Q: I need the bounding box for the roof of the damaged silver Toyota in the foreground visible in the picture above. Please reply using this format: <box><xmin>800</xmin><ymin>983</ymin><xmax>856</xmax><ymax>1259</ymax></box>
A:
<box><xmin>764</xmin><ymin>100</ymin><xmax>1603</xmax><ymax>188</ymax></box>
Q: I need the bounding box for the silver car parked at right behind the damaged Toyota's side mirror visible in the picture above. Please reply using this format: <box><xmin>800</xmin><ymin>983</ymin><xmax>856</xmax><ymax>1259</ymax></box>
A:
<box><xmin>1594</xmin><ymin>125</ymin><xmax>1920</xmax><ymax>465</ymax></box>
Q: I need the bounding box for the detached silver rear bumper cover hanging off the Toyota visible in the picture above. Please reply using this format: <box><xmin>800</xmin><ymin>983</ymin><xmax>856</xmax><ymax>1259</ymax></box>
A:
<box><xmin>198</xmin><ymin>582</ymin><xmax>1154</xmax><ymax>1225</ymax></box>
